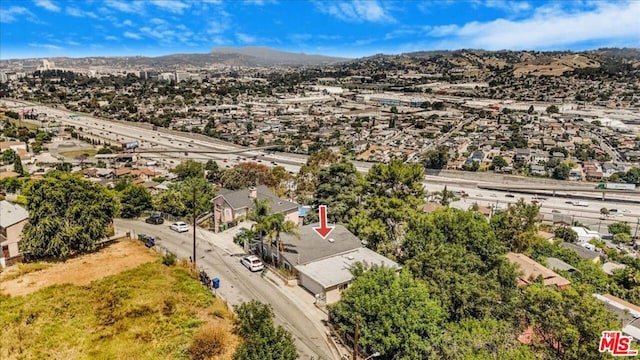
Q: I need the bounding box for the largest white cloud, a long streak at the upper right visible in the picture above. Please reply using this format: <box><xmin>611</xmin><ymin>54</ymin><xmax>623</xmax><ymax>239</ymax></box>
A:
<box><xmin>428</xmin><ymin>1</ymin><xmax>640</xmax><ymax>50</ymax></box>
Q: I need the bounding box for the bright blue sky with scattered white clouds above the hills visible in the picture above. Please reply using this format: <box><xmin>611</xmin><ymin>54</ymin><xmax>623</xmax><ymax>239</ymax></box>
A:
<box><xmin>0</xmin><ymin>0</ymin><xmax>640</xmax><ymax>59</ymax></box>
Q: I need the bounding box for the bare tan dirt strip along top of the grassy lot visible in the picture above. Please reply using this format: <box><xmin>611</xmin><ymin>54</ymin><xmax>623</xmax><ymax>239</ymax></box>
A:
<box><xmin>0</xmin><ymin>240</ymin><xmax>159</xmax><ymax>296</ymax></box>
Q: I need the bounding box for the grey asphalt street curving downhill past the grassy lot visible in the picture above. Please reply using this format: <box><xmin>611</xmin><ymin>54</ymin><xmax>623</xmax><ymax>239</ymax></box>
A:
<box><xmin>115</xmin><ymin>219</ymin><xmax>337</xmax><ymax>360</ymax></box>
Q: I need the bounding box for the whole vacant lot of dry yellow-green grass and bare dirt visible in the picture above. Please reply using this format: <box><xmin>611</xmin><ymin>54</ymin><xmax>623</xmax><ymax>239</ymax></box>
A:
<box><xmin>0</xmin><ymin>240</ymin><xmax>239</xmax><ymax>360</ymax></box>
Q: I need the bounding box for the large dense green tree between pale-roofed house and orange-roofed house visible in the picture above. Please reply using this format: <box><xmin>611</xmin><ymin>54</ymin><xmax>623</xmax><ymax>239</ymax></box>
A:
<box><xmin>400</xmin><ymin>208</ymin><xmax>517</xmax><ymax>321</ymax></box>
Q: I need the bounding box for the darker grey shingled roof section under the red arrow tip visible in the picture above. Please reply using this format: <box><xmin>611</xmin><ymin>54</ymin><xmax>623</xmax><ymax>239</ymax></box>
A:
<box><xmin>280</xmin><ymin>224</ymin><xmax>362</xmax><ymax>267</ymax></box>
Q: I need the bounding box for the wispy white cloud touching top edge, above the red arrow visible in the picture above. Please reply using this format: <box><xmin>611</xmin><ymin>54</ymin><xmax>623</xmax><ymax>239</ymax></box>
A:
<box><xmin>315</xmin><ymin>0</ymin><xmax>395</xmax><ymax>23</ymax></box>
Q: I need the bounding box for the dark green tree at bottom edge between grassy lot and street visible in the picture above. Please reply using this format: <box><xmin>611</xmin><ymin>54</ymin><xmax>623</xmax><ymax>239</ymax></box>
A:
<box><xmin>233</xmin><ymin>300</ymin><xmax>298</xmax><ymax>360</ymax></box>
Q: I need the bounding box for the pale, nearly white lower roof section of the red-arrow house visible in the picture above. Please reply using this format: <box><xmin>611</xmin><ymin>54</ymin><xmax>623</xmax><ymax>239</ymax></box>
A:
<box><xmin>296</xmin><ymin>247</ymin><xmax>400</xmax><ymax>289</ymax></box>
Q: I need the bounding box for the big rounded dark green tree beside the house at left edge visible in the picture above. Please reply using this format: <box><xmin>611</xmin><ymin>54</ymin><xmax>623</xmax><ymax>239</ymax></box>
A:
<box><xmin>20</xmin><ymin>173</ymin><xmax>116</xmax><ymax>258</ymax></box>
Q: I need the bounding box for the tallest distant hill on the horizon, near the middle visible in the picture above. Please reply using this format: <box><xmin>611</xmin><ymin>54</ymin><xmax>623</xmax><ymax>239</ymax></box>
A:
<box><xmin>211</xmin><ymin>46</ymin><xmax>349</xmax><ymax>65</ymax></box>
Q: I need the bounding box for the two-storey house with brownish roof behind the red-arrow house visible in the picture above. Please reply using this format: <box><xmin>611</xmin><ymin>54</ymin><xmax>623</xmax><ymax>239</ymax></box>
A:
<box><xmin>211</xmin><ymin>185</ymin><xmax>299</xmax><ymax>231</ymax></box>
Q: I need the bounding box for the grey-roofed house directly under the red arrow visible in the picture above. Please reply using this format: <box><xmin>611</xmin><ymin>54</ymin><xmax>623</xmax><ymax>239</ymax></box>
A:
<box><xmin>276</xmin><ymin>224</ymin><xmax>400</xmax><ymax>304</ymax></box>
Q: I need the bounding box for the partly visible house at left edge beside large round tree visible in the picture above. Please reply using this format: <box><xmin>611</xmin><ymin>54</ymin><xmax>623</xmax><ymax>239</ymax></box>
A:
<box><xmin>0</xmin><ymin>200</ymin><xmax>29</xmax><ymax>267</ymax></box>
